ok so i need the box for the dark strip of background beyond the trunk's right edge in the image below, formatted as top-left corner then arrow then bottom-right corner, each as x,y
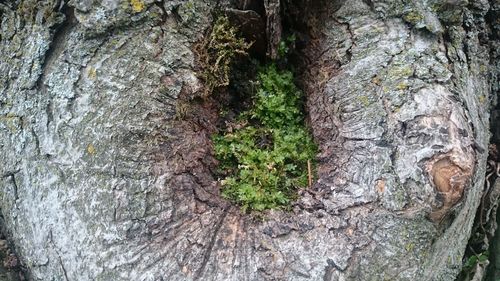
457,1 -> 500,281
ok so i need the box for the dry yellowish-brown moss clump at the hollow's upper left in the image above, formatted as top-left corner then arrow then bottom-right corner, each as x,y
201,16 -> 252,96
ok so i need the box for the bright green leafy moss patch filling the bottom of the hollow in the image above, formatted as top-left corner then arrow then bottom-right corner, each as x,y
213,64 -> 317,211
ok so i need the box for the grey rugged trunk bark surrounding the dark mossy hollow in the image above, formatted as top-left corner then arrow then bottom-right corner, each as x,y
0,0 -> 499,280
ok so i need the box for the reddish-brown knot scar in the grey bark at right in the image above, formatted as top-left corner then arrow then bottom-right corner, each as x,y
427,150 -> 474,221
